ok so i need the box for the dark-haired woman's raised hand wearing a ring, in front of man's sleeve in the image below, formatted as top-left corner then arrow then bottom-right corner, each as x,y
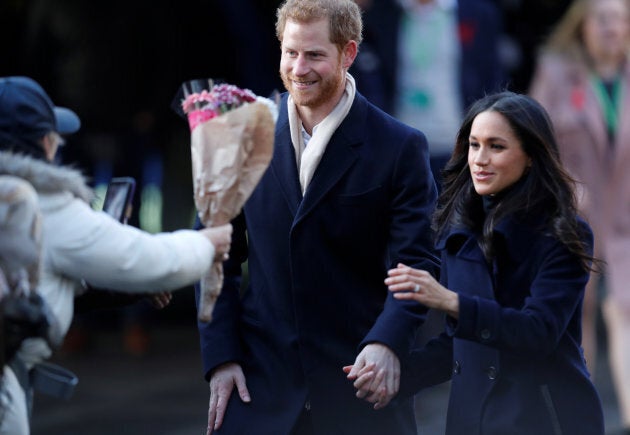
385,263 -> 459,319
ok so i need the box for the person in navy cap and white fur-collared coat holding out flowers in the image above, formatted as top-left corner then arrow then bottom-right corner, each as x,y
0,77 -> 232,434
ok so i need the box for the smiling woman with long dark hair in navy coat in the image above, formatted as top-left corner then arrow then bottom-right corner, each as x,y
348,92 -> 604,435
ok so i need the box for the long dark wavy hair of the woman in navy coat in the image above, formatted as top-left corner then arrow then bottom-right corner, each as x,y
433,92 -> 594,270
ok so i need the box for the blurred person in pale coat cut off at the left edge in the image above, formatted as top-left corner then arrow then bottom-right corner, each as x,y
0,175 -> 55,434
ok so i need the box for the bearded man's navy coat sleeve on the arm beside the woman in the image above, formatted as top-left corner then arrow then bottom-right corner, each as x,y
362,126 -> 440,358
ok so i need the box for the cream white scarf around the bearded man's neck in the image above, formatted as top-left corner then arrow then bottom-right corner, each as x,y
287,73 -> 356,194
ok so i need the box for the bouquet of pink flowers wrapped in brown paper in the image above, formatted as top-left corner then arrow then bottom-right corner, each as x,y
181,80 -> 277,322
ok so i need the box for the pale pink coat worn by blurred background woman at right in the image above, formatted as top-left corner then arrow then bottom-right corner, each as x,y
530,54 -> 630,313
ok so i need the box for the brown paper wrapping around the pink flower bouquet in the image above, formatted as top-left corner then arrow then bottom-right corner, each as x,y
190,101 -> 275,322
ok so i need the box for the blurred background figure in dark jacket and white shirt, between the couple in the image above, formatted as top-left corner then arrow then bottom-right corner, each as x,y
351,0 -> 505,191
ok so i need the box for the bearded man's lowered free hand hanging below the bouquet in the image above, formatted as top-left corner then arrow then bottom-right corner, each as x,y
206,363 -> 251,435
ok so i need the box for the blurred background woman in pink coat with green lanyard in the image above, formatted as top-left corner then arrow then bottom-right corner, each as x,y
530,0 -> 630,433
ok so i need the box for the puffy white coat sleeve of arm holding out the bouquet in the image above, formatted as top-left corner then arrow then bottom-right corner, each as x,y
44,199 -> 214,293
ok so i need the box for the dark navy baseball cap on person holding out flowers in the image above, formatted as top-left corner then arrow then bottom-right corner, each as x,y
0,77 -> 81,155
